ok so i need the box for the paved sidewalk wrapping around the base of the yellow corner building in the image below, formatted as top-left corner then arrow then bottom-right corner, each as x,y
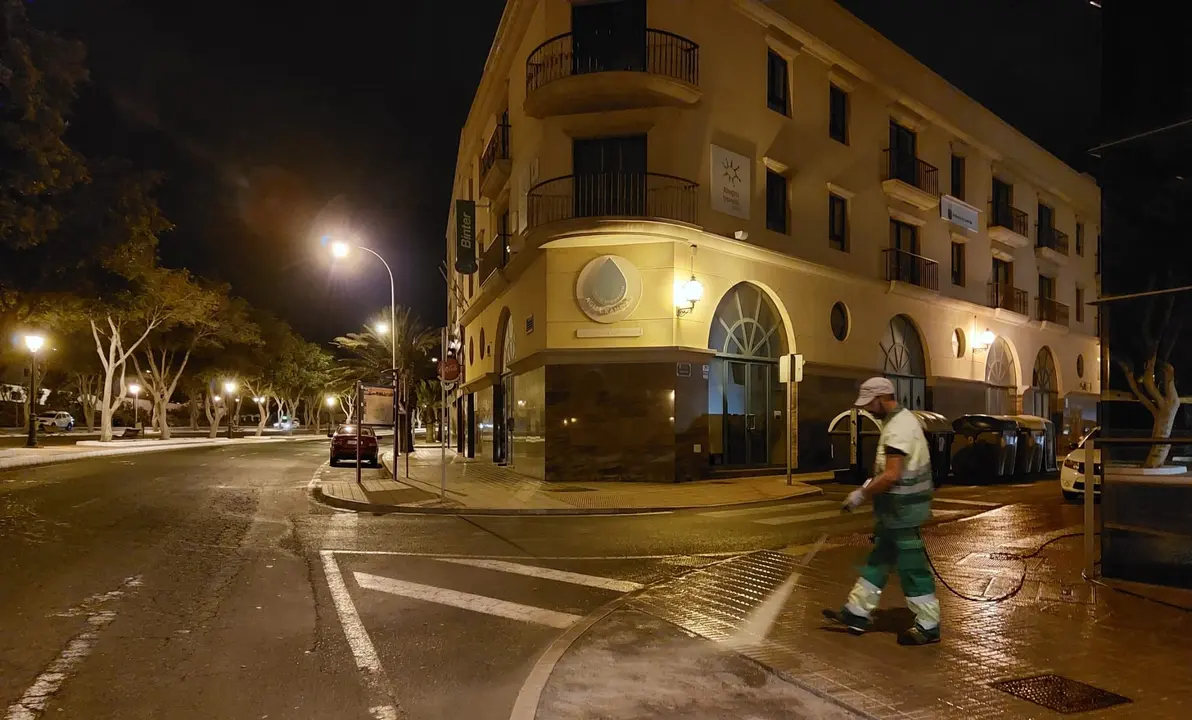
311,446 -> 830,515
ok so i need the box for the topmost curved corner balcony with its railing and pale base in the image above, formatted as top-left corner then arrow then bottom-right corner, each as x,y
524,30 -> 701,118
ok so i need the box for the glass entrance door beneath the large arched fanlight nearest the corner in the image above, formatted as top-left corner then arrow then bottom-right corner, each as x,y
722,360 -> 781,467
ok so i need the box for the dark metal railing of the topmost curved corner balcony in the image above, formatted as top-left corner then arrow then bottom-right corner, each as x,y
526,29 -> 700,93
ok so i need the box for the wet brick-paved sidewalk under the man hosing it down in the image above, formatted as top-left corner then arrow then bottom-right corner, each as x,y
633,505 -> 1192,720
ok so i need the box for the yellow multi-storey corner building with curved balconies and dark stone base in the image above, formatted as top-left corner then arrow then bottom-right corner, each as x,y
447,0 -> 1100,482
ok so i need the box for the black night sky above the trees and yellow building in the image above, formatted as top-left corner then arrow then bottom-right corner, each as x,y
31,0 -> 1100,340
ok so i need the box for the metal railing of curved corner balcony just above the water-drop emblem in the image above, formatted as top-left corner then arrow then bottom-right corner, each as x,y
527,173 -> 700,228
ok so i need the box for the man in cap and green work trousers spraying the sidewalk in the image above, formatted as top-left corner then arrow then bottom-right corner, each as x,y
824,378 -> 939,645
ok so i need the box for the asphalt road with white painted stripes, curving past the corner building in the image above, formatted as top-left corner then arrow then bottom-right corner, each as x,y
0,441 -> 1058,720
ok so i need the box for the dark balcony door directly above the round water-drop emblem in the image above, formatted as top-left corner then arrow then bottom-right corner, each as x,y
571,135 -> 646,217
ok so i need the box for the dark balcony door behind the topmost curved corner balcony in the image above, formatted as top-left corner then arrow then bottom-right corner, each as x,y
571,0 -> 646,75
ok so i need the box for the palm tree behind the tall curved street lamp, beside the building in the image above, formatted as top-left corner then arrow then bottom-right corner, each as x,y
331,306 -> 437,451
